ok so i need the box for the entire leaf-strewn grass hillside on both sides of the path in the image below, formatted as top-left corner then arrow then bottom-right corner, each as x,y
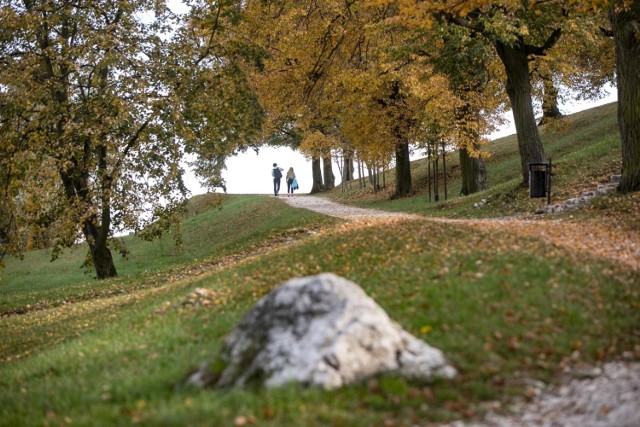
0,102 -> 640,426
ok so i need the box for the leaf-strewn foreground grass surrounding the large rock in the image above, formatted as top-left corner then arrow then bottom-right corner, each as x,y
0,216 -> 640,426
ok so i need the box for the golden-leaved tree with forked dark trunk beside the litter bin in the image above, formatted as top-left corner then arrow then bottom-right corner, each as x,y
384,1 -> 566,183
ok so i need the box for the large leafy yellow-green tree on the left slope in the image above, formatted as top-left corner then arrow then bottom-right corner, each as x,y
0,0 -> 258,279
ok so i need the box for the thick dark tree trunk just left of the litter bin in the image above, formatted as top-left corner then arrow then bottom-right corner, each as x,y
495,41 -> 545,184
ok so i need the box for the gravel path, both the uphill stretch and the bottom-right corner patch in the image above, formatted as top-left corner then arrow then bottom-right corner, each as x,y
283,196 -> 640,427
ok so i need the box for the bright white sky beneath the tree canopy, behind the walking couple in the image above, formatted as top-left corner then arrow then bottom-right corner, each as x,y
185,89 -> 617,195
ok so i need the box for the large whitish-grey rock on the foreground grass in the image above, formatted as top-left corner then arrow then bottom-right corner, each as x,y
186,273 -> 456,389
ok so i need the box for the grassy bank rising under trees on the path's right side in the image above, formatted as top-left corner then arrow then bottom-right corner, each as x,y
330,103 -> 621,217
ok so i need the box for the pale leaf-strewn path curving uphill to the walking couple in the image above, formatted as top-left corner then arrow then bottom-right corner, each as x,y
282,196 -> 640,271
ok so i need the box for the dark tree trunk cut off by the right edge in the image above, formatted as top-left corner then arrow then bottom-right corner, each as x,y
609,1 -> 640,193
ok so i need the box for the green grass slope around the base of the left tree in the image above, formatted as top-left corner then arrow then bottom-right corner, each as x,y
0,196 -> 336,314
